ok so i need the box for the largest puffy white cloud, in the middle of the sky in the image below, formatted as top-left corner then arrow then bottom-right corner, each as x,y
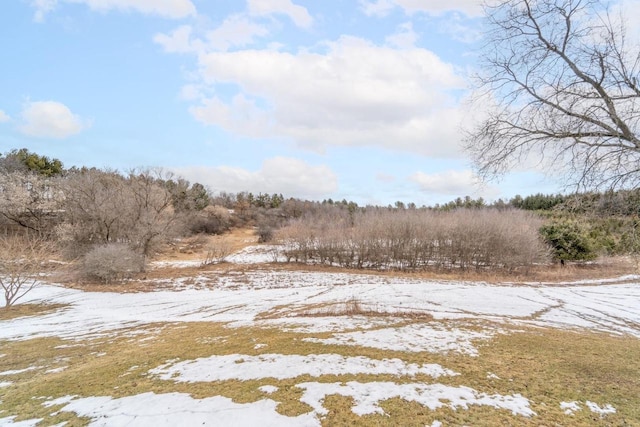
191,37 -> 464,156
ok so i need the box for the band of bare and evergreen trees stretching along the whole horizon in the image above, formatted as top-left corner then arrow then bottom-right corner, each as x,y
0,149 -> 640,278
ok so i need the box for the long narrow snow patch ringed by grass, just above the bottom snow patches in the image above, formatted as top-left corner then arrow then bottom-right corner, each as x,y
149,354 -> 458,382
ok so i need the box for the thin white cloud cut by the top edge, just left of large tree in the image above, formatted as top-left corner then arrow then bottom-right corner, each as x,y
360,0 -> 482,17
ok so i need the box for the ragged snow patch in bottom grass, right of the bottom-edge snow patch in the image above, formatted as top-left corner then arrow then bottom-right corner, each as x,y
296,381 -> 535,417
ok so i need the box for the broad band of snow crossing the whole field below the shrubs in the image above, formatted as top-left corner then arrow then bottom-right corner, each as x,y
0,270 -> 640,344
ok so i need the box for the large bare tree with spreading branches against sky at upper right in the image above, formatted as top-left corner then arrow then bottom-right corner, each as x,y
466,0 -> 640,189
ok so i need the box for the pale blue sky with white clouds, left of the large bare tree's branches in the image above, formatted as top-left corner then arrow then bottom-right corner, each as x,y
0,0 -> 635,206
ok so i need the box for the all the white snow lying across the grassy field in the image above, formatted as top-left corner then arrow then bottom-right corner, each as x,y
0,247 -> 640,426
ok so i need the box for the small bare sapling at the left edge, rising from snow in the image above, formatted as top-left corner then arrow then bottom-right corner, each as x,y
0,235 -> 51,309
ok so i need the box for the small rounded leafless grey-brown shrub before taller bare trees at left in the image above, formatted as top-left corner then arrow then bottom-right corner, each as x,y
81,243 -> 144,283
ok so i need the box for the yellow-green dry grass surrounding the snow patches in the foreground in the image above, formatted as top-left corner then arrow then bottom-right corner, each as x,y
0,323 -> 640,426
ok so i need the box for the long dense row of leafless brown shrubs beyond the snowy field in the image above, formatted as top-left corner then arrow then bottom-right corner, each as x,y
278,209 -> 548,270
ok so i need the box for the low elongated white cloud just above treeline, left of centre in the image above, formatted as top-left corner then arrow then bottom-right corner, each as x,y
173,157 -> 338,198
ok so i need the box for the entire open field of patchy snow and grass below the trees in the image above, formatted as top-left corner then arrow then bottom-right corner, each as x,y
0,246 -> 640,427
